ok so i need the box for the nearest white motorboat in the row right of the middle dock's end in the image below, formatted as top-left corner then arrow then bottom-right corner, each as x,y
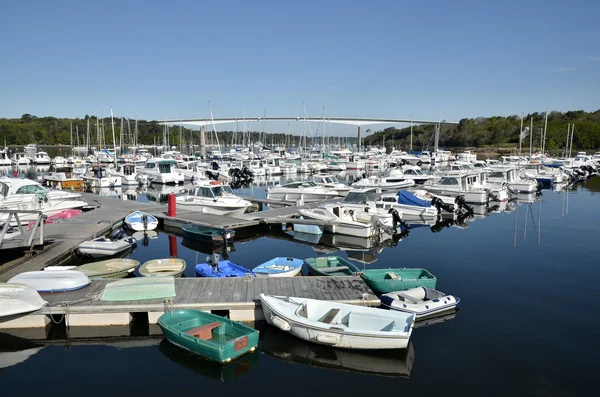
298,203 -> 395,238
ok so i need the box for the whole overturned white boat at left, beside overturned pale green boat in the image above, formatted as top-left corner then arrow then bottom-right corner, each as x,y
8,270 -> 91,292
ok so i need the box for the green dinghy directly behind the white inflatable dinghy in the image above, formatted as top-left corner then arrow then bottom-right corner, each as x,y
360,268 -> 437,294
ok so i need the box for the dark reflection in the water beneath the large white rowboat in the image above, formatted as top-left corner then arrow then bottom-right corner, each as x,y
259,324 -> 415,378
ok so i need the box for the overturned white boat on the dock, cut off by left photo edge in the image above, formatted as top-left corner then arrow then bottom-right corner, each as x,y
0,282 -> 48,322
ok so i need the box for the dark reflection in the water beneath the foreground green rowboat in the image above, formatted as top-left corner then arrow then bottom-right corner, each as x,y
158,339 -> 259,383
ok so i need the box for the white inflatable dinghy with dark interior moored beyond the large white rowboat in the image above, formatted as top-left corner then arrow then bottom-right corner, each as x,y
381,287 -> 460,320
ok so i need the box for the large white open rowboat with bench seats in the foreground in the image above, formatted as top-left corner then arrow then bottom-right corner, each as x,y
260,293 -> 415,349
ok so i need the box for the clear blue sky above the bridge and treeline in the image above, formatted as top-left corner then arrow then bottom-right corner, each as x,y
0,0 -> 600,135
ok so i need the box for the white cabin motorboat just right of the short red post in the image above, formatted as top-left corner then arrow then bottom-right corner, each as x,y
175,180 -> 252,216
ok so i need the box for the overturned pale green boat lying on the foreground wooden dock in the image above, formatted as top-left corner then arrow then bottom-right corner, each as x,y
100,276 -> 176,302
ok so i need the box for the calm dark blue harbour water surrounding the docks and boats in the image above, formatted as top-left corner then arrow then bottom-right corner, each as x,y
0,171 -> 600,397
